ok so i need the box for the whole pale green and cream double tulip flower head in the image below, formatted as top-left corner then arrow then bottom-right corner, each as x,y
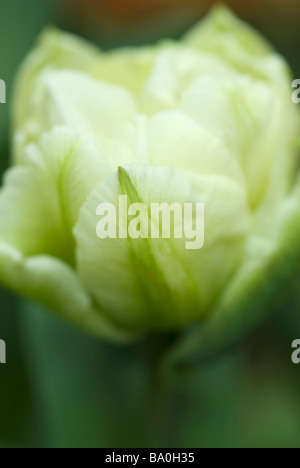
0,4 -> 300,348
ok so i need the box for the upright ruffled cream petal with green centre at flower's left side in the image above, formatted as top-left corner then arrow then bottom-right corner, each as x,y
0,128 -> 108,262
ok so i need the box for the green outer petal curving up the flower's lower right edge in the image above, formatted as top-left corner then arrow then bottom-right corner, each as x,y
165,184 -> 300,366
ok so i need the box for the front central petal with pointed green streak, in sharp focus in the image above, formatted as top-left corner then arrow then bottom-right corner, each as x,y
75,165 -> 249,330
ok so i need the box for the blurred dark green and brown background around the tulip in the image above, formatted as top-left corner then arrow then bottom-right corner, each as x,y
0,0 -> 300,448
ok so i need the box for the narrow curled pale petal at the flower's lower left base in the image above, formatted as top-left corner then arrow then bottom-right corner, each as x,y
0,242 -> 132,342
